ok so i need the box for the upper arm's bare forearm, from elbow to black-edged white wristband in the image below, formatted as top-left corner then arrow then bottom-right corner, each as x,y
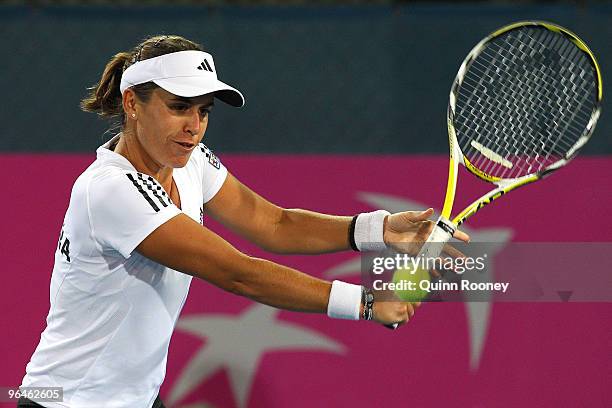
260,209 -> 352,254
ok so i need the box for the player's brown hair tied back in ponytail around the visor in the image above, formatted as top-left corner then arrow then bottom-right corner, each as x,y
81,35 -> 203,123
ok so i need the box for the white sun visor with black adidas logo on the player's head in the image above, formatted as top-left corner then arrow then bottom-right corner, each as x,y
119,51 -> 244,107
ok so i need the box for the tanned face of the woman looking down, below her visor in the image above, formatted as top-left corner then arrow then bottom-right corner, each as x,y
136,88 -> 214,168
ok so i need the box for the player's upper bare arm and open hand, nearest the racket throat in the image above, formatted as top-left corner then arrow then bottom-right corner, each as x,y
206,174 -> 469,256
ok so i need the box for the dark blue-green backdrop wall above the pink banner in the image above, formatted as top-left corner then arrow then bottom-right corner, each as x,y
0,4 -> 612,154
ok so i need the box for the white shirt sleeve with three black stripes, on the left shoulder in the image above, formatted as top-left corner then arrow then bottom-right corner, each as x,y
88,172 -> 181,258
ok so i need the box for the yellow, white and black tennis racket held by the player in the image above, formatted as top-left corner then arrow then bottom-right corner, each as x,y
393,21 -> 602,327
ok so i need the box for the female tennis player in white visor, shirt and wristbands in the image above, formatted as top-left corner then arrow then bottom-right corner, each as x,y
18,36 -> 468,408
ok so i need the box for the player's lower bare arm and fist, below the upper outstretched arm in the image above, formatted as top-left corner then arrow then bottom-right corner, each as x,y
136,214 -> 414,324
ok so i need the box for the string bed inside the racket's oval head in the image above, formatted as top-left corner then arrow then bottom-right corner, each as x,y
454,27 -> 595,178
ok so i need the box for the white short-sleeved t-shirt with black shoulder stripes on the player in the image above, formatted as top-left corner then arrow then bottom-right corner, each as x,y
22,135 -> 227,408
